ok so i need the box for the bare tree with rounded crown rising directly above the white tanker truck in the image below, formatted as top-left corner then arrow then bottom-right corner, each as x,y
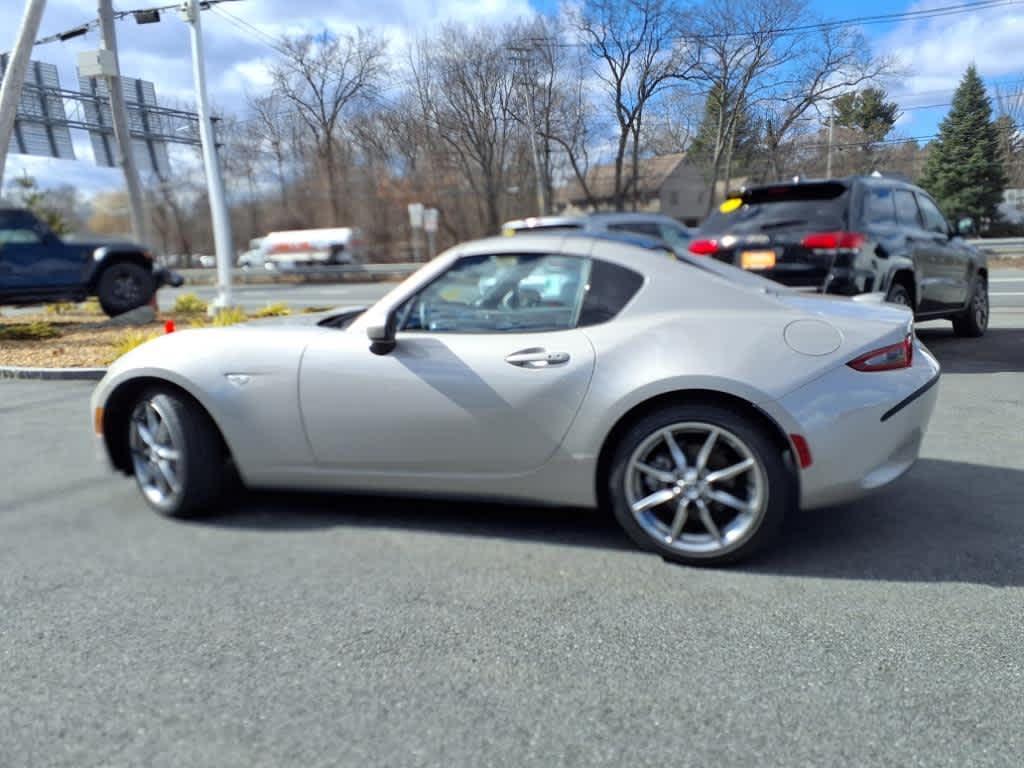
272,29 -> 387,223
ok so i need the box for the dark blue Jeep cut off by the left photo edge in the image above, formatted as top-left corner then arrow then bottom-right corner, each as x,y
0,206 -> 182,316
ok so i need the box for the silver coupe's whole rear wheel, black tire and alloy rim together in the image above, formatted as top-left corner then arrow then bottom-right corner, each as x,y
608,403 -> 795,565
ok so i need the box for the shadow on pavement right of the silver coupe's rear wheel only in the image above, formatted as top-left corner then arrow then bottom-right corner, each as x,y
744,459 -> 1024,587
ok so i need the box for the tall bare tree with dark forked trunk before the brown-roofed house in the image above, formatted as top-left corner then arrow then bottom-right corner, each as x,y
568,0 -> 693,211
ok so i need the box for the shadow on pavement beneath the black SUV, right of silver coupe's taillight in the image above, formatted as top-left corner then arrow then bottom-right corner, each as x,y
918,324 -> 1024,374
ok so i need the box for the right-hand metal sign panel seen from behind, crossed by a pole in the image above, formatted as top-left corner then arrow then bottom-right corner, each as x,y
78,73 -> 172,178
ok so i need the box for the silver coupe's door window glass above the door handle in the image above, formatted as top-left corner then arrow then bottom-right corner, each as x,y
398,254 -> 590,334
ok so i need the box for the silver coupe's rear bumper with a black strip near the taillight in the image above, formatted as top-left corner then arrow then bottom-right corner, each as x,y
780,340 -> 940,508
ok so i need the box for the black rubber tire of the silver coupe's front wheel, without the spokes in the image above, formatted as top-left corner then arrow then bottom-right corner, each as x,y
124,388 -> 226,518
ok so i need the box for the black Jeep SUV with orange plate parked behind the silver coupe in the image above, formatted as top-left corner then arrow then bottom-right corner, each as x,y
689,176 -> 988,336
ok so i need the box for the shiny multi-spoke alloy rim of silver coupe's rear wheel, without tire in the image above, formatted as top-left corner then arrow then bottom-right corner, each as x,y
624,422 -> 768,556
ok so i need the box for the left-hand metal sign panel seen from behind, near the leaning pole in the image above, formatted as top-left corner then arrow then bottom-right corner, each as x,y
0,53 -> 75,160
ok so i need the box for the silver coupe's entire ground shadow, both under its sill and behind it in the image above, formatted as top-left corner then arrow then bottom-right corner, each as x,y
203,459 -> 1024,587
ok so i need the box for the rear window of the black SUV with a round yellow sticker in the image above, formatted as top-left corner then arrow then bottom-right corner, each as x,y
700,181 -> 849,234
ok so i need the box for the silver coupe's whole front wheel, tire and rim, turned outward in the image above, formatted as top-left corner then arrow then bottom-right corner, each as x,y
127,389 -> 227,517
